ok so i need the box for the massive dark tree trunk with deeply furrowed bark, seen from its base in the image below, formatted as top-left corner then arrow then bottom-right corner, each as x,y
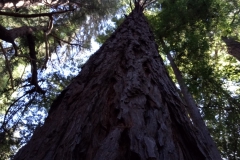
15,8 -> 219,160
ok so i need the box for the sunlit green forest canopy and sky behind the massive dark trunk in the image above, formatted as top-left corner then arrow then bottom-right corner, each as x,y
0,0 -> 240,160
